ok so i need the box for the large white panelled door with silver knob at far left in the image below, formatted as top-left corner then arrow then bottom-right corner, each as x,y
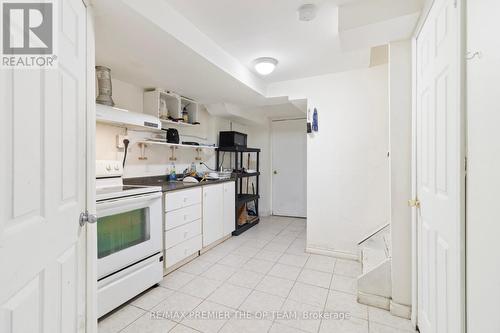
0,0 -> 86,333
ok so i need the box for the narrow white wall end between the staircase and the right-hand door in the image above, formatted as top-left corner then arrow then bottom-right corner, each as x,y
389,41 -> 412,308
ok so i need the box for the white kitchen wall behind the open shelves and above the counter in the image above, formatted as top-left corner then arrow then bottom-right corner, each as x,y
96,79 -> 271,216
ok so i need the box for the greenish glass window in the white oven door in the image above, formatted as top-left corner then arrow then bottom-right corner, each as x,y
97,208 -> 150,259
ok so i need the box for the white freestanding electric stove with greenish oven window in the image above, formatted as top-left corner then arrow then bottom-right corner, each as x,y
96,161 -> 163,317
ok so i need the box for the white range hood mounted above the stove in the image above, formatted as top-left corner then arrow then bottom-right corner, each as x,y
96,104 -> 161,130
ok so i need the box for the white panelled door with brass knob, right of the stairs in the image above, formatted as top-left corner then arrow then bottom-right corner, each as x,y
416,0 -> 465,333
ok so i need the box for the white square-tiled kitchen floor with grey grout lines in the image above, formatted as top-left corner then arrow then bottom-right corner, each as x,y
99,217 -> 414,333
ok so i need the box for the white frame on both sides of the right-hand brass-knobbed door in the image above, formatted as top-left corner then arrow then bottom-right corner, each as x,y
411,0 -> 467,333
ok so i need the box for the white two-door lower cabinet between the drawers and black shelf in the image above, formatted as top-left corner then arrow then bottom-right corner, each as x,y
202,182 -> 235,247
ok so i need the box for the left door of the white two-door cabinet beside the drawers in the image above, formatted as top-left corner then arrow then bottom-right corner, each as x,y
202,184 -> 224,246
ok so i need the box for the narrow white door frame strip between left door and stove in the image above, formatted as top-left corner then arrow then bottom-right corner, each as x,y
82,0 -> 97,333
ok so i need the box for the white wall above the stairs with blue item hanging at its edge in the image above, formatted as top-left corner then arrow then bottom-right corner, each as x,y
269,65 -> 389,258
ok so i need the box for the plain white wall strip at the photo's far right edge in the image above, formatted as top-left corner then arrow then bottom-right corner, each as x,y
466,0 -> 500,333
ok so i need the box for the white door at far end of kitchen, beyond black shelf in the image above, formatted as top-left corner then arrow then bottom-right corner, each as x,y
272,119 -> 307,217
